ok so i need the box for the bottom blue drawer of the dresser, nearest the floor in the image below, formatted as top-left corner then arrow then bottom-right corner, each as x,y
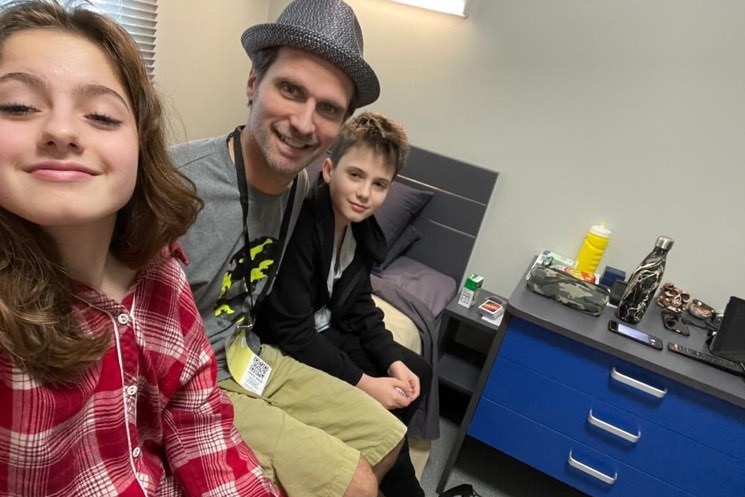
468,398 -> 703,497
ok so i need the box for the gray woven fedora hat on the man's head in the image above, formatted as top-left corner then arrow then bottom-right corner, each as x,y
241,0 -> 380,107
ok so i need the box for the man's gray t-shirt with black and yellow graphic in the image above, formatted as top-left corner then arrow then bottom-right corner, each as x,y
169,136 -> 308,381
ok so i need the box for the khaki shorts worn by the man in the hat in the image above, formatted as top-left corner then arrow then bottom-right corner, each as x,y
220,345 -> 406,497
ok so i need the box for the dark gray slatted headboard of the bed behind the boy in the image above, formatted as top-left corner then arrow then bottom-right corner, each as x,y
308,147 -> 498,285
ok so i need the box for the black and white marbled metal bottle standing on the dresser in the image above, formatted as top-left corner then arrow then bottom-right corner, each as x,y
616,236 -> 673,324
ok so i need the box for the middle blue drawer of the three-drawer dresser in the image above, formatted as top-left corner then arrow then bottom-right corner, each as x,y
483,358 -> 745,497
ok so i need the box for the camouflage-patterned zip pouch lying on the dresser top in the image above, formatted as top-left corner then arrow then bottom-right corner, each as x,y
528,266 -> 610,316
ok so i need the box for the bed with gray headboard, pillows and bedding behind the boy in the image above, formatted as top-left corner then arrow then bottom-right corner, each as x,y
308,147 -> 498,475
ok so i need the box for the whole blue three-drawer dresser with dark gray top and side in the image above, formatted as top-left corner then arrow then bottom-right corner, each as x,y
440,270 -> 745,497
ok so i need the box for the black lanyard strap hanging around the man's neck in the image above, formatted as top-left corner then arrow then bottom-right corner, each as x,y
231,126 -> 297,320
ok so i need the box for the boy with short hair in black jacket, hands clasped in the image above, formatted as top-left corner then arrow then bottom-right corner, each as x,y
256,112 -> 432,496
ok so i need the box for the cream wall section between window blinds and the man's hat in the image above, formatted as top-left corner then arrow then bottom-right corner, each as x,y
155,0 -> 269,142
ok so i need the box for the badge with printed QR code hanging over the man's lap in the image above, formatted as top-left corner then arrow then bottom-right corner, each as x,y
226,321 -> 272,395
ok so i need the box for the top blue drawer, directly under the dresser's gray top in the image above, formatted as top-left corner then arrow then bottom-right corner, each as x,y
498,317 -> 745,461
